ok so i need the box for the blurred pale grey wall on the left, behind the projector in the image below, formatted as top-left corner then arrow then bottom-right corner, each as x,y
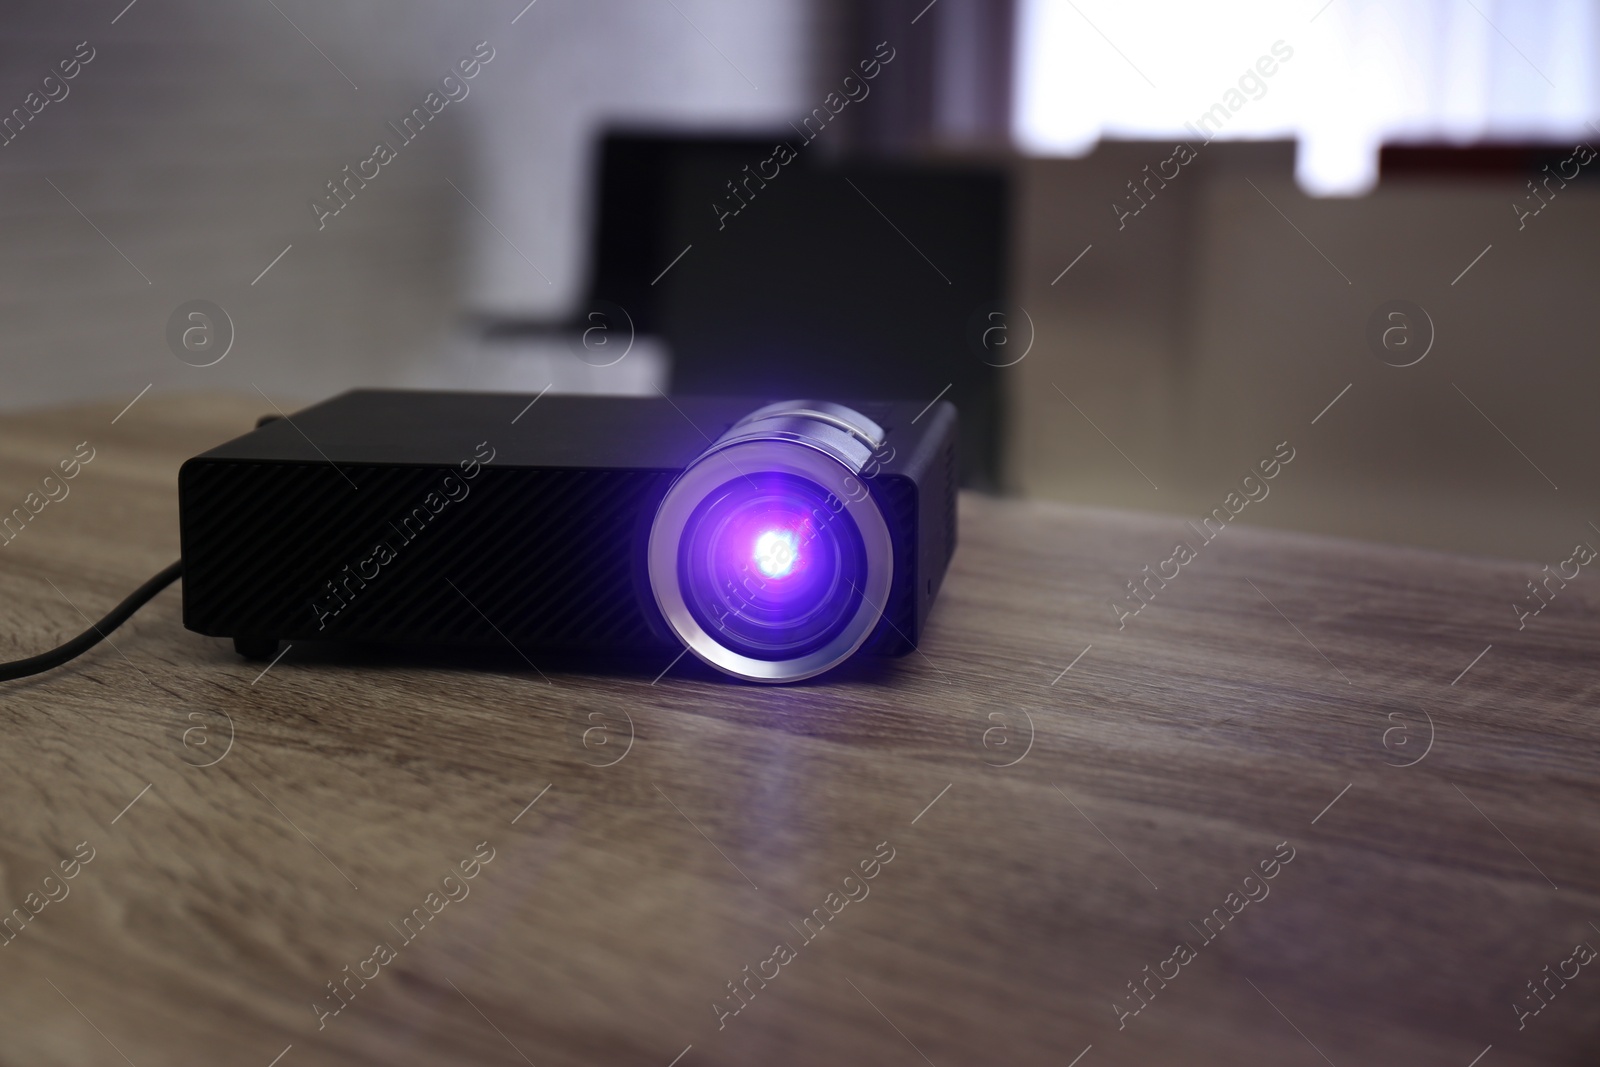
0,0 -> 819,408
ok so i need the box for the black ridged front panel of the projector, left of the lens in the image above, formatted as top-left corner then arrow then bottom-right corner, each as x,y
182,462 -> 672,651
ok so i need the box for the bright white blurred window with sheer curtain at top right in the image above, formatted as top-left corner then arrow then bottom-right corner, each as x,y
1013,0 -> 1600,195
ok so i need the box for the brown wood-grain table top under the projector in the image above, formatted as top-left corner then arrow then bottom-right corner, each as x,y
0,395 -> 1600,1067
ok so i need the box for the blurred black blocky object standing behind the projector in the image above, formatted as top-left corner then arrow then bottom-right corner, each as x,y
590,133 -> 1008,490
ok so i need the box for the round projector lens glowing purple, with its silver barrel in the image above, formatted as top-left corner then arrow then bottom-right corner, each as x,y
650,402 -> 893,681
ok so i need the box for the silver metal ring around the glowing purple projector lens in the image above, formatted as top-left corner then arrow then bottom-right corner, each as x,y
648,422 -> 894,683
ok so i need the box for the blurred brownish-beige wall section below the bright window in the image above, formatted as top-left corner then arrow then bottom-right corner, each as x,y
1008,142 -> 1600,560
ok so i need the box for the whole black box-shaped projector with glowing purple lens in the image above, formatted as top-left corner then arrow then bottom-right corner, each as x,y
179,390 -> 957,681
